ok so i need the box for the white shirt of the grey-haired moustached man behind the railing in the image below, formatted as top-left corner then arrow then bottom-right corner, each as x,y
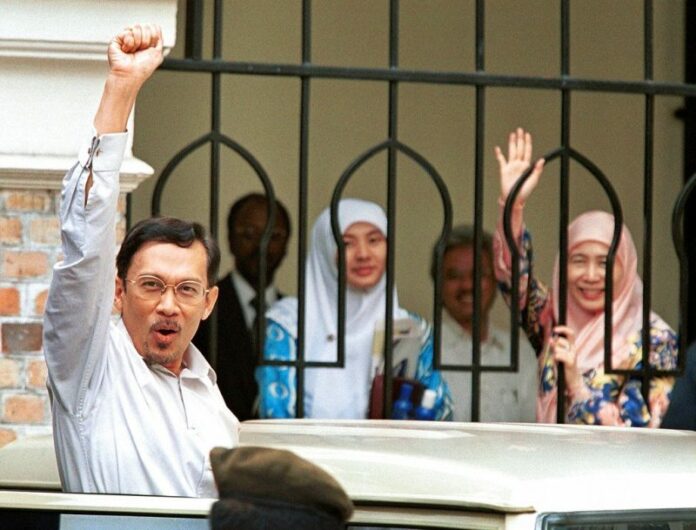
442,310 -> 537,422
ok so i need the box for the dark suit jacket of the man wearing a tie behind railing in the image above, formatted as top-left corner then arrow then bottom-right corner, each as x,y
193,274 -> 259,421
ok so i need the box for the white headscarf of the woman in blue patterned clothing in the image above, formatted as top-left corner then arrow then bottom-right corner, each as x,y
268,199 -> 407,419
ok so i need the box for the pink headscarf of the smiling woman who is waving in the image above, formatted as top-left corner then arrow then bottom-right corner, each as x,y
537,210 -> 643,422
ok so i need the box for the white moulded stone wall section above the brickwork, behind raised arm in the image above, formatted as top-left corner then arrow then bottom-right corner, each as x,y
0,0 -> 177,182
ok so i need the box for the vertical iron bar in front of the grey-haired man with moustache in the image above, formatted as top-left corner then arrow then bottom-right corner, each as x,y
471,0 -> 486,421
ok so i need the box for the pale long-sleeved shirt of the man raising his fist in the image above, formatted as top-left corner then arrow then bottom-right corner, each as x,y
44,133 -> 239,497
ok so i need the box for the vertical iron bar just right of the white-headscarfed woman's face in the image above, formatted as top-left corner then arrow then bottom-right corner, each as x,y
383,0 -> 399,418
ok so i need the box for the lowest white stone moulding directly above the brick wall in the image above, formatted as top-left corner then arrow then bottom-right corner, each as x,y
0,155 -> 155,193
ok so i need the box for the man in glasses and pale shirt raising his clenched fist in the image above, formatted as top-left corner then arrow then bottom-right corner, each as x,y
44,25 -> 239,497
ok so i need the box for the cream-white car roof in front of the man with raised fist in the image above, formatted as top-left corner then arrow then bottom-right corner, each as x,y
0,420 -> 696,514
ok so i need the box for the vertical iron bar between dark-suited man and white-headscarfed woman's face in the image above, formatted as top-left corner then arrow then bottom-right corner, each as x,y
295,0 -> 312,418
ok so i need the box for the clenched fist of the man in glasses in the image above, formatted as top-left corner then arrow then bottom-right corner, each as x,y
108,24 -> 164,84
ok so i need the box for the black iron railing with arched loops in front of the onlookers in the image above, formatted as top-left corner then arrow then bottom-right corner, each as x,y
145,0 -> 696,421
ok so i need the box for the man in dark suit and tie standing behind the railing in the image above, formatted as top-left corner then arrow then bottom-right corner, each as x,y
193,193 -> 290,421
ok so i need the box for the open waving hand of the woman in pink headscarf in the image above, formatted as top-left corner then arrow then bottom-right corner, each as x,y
495,127 -> 544,205
